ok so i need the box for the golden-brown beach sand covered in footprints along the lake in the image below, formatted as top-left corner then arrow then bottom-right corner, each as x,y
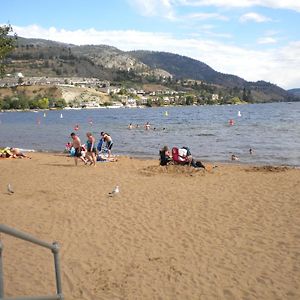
0,153 -> 300,300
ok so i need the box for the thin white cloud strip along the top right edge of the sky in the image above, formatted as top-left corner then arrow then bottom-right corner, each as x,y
175,0 -> 300,12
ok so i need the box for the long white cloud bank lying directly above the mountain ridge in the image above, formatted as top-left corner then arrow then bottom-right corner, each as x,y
13,25 -> 300,88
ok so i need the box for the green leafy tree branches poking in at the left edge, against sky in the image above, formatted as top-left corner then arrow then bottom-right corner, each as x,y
0,25 -> 17,77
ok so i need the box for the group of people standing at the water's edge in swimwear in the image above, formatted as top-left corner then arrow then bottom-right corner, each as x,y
66,132 -> 114,166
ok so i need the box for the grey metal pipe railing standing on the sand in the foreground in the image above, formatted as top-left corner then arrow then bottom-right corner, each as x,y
0,224 -> 64,300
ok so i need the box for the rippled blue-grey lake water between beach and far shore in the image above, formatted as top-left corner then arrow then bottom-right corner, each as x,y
0,102 -> 300,166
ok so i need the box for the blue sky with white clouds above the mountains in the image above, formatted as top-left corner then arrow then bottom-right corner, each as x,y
0,0 -> 300,89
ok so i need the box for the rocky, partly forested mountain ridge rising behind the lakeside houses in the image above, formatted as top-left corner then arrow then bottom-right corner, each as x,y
2,37 -> 299,102
